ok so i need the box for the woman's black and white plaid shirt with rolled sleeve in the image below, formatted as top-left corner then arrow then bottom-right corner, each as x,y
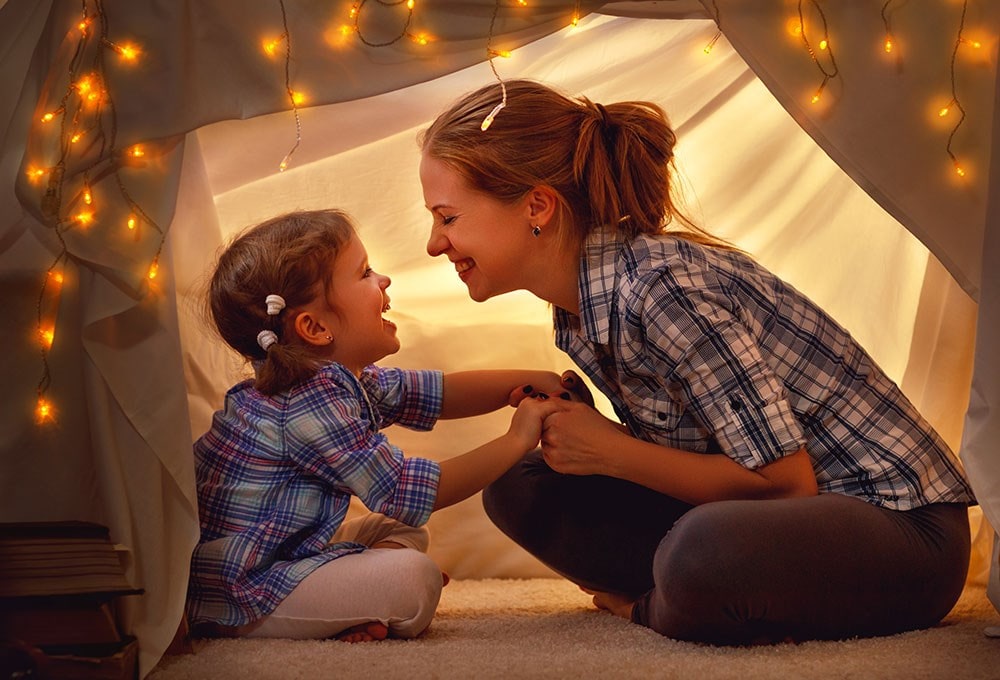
554,234 -> 975,510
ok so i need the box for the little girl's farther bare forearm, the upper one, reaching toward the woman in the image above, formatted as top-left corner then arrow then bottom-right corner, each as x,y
441,369 -> 559,419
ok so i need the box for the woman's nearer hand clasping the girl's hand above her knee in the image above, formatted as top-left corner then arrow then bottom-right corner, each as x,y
542,400 -> 630,476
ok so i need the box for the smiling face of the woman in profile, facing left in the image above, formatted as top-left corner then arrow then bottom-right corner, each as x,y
420,154 -> 538,302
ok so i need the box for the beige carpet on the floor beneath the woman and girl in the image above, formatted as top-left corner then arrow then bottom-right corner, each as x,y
148,579 -> 1000,680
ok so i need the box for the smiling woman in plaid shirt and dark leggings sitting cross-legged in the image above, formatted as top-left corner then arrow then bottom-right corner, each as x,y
420,81 -> 975,644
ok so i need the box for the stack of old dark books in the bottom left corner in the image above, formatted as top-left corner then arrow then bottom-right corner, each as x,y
0,521 -> 142,678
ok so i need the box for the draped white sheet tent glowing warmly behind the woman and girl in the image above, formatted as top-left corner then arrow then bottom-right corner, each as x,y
0,0 -> 1000,675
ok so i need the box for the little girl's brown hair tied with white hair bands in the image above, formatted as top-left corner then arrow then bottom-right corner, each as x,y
207,210 -> 355,395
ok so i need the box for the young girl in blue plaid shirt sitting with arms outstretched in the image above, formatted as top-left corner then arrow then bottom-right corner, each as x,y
188,210 -> 579,641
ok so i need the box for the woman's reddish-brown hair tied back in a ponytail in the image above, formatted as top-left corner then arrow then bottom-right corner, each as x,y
419,80 -> 730,248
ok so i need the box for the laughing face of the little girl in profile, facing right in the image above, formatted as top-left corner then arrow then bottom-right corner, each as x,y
306,235 -> 399,375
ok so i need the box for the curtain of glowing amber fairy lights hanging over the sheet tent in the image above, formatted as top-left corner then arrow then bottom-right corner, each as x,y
24,0 -> 982,423
